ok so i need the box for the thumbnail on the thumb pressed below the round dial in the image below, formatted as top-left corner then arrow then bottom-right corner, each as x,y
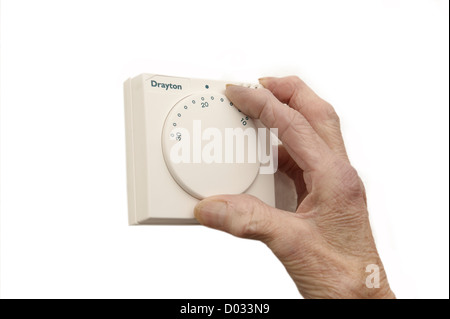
194,200 -> 227,228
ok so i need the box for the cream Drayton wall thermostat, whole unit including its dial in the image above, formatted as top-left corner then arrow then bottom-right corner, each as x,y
124,74 -> 278,225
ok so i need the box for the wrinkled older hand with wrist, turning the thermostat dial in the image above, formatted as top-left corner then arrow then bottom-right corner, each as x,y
195,77 -> 395,298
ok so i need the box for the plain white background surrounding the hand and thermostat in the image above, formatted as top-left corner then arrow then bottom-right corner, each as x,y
0,0 -> 449,298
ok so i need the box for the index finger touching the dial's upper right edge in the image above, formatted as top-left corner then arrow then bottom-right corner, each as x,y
226,85 -> 333,172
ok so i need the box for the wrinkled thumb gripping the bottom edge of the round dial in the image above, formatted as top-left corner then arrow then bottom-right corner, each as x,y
194,195 -> 306,255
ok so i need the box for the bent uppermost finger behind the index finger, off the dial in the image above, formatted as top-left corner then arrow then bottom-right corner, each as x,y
259,76 -> 347,159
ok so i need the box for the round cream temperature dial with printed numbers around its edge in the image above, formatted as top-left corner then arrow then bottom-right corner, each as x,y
162,92 -> 260,199
